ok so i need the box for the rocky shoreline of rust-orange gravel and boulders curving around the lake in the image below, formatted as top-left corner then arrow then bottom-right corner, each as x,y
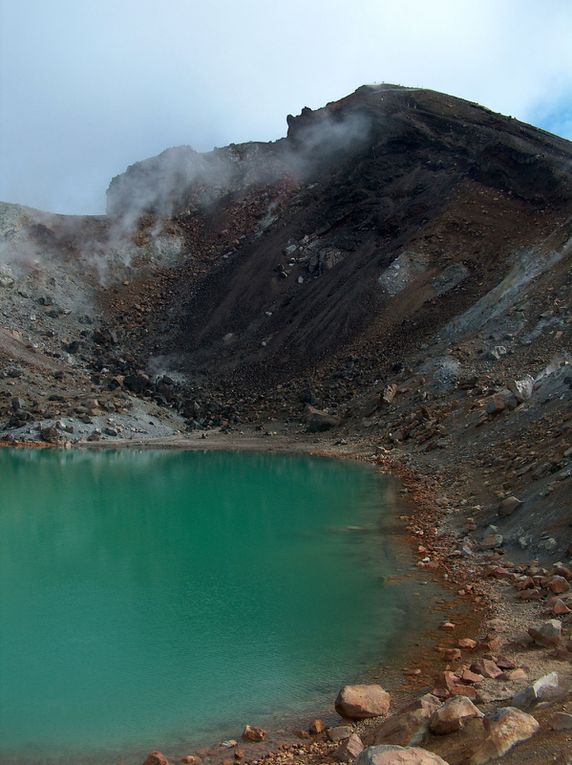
6,432 -> 572,765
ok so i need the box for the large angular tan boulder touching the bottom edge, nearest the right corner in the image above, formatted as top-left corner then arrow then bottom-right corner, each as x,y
467,707 -> 540,765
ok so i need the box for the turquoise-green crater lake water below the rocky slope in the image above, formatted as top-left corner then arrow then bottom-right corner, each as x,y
0,449 -> 403,757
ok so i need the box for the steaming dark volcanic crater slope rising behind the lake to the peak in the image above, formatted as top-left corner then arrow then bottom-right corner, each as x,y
0,86 -> 572,559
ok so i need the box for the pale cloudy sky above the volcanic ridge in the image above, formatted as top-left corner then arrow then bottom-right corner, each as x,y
0,0 -> 572,213
